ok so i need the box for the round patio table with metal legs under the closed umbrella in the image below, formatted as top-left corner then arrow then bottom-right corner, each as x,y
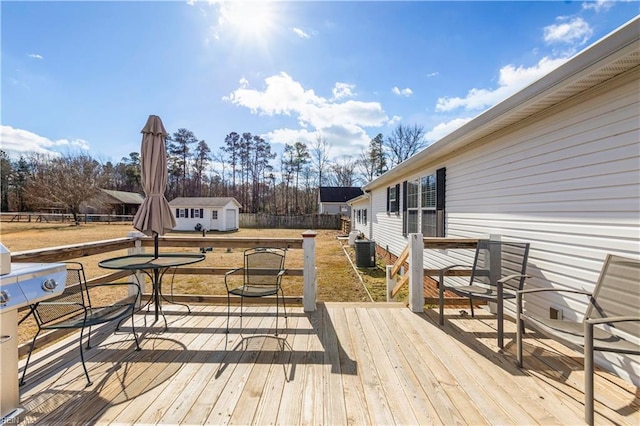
98,253 -> 205,329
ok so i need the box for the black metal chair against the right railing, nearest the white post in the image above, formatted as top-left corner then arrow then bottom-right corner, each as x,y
439,240 -> 530,325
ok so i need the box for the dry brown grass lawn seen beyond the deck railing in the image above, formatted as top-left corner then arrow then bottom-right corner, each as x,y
0,222 -> 384,341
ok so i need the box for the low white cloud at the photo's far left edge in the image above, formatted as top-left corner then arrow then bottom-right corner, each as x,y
0,125 -> 89,157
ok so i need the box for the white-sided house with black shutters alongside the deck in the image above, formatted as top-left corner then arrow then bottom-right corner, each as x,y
362,18 -> 640,385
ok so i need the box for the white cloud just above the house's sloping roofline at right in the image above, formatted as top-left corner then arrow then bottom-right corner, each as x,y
436,57 -> 567,112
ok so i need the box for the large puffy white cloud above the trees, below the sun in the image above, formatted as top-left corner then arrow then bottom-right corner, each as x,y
223,72 -> 388,151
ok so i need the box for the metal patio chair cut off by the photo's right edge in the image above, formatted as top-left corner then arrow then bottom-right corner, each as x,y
516,255 -> 640,425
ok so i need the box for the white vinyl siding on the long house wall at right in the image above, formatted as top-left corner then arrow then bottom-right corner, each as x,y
364,68 -> 640,384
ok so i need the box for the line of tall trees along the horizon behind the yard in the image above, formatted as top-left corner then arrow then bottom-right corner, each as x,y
0,124 -> 426,220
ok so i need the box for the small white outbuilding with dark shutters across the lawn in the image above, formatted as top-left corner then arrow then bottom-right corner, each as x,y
169,197 -> 242,231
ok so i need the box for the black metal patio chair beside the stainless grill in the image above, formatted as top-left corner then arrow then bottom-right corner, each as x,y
20,262 -> 140,386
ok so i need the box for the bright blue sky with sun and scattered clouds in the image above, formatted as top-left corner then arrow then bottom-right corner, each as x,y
0,1 -> 639,162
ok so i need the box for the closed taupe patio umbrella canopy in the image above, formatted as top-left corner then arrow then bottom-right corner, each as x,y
133,115 -> 176,235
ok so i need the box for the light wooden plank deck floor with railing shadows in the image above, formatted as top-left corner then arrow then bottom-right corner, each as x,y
21,303 -> 640,425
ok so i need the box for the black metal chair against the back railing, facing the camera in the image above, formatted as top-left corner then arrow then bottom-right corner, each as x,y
224,247 -> 287,336
